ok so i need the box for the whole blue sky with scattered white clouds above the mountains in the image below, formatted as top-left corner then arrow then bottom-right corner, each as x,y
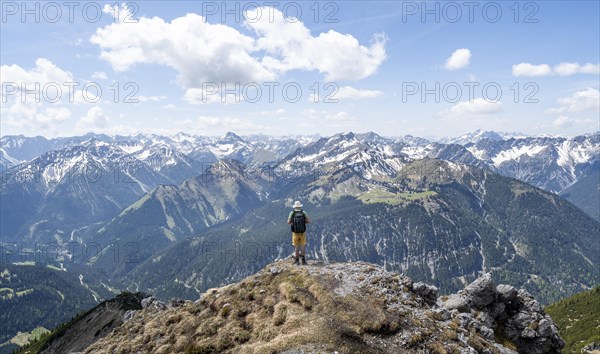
0,1 -> 600,137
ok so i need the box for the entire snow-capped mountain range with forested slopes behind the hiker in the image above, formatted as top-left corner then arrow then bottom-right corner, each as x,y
0,132 -> 600,352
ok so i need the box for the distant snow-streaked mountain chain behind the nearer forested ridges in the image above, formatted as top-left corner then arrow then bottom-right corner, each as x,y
0,131 -> 600,246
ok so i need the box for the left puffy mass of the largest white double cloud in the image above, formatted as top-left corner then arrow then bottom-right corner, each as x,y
90,13 -> 274,87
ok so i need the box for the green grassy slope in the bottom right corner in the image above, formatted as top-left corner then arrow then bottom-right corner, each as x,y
546,286 -> 600,353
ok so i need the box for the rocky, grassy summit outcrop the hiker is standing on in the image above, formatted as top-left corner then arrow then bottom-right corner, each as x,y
47,260 -> 564,354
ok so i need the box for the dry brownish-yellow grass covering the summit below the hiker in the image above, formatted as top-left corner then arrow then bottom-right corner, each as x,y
86,260 -> 500,354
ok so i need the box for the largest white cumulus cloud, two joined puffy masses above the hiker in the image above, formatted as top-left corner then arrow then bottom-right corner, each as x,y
90,7 -> 386,88
